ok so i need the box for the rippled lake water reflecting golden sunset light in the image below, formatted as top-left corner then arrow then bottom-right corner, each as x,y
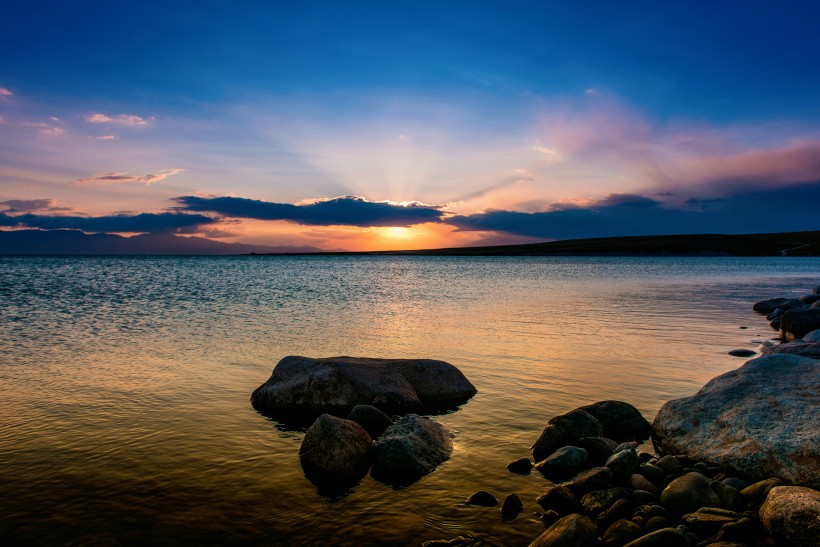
0,257 -> 820,545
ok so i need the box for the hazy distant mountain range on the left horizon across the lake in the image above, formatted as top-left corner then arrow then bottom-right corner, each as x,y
0,230 -> 322,255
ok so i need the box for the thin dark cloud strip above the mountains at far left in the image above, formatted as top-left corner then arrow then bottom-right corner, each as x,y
0,213 -> 219,233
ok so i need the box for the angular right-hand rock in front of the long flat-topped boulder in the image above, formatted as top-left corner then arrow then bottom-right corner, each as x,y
372,414 -> 453,483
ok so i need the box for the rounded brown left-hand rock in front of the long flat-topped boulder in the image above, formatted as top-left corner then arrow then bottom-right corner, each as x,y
299,414 -> 373,483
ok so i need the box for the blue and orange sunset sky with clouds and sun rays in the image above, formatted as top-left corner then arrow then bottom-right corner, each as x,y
0,0 -> 820,250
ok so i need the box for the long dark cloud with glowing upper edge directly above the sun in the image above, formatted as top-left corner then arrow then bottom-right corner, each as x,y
176,196 -> 444,227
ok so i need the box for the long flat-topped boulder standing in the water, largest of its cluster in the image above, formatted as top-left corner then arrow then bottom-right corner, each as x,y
251,356 -> 476,415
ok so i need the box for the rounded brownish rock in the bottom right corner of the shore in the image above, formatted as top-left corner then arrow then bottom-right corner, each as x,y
760,486 -> 820,547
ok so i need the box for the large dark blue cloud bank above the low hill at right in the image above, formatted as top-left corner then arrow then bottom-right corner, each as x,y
446,182 -> 820,239
